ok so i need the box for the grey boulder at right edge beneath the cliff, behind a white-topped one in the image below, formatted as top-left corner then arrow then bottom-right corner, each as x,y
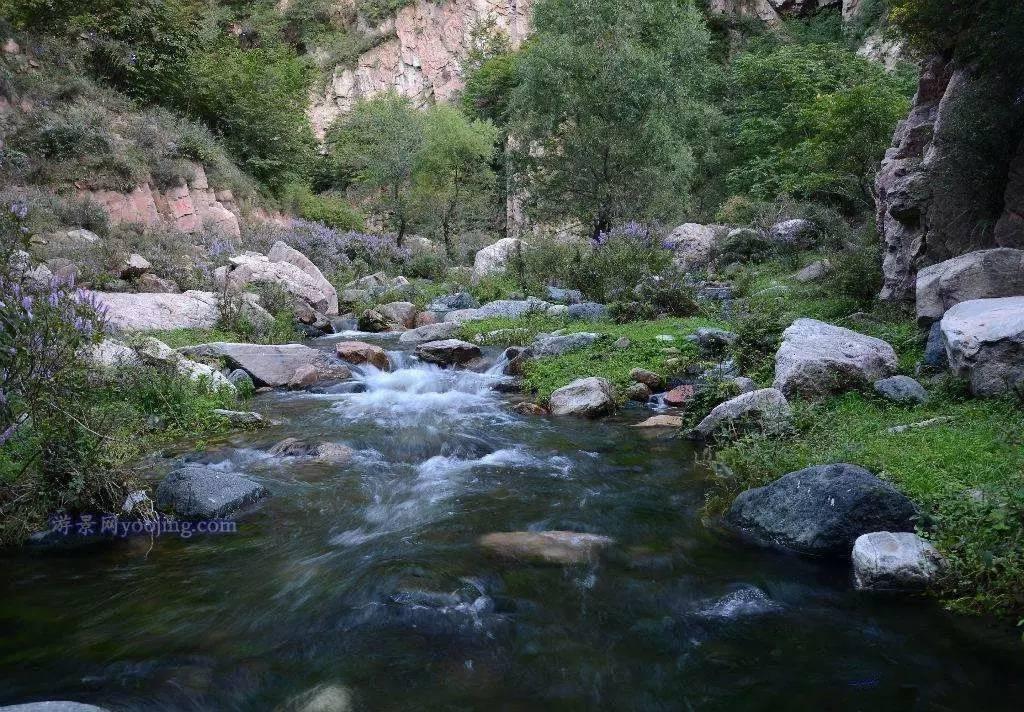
916,247 -> 1024,326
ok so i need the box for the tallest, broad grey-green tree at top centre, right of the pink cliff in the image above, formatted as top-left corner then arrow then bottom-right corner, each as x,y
509,0 -> 715,237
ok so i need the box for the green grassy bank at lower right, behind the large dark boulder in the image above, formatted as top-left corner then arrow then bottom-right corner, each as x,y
711,389 -> 1024,617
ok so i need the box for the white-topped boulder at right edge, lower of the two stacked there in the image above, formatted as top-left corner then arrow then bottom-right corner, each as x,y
941,296 -> 1024,395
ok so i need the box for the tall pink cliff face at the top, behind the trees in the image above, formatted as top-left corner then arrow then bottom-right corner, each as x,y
309,0 -> 532,138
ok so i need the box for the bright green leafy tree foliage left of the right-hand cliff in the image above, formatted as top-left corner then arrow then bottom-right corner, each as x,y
728,43 -> 911,209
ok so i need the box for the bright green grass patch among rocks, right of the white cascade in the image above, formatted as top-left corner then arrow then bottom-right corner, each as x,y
460,317 -> 722,402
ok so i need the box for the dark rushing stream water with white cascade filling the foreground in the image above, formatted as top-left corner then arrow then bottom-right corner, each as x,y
0,339 -> 1024,712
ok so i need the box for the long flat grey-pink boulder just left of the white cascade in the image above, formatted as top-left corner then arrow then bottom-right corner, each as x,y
178,341 -> 352,388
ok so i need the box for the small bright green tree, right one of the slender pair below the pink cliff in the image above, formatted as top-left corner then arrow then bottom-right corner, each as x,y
414,104 -> 498,257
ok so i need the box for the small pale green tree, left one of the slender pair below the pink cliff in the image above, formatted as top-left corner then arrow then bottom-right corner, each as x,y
327,93 -> 424,245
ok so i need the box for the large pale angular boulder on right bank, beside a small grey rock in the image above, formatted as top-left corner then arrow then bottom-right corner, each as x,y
773,319 -> 897,396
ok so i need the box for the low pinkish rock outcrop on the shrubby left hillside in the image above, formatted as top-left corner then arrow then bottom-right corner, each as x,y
78,164 -> 242,237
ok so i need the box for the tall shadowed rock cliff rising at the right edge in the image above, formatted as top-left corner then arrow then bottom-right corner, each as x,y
876,57 -> 1024,301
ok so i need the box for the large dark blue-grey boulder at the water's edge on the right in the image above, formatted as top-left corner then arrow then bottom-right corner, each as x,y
726,464 -> 916,556
